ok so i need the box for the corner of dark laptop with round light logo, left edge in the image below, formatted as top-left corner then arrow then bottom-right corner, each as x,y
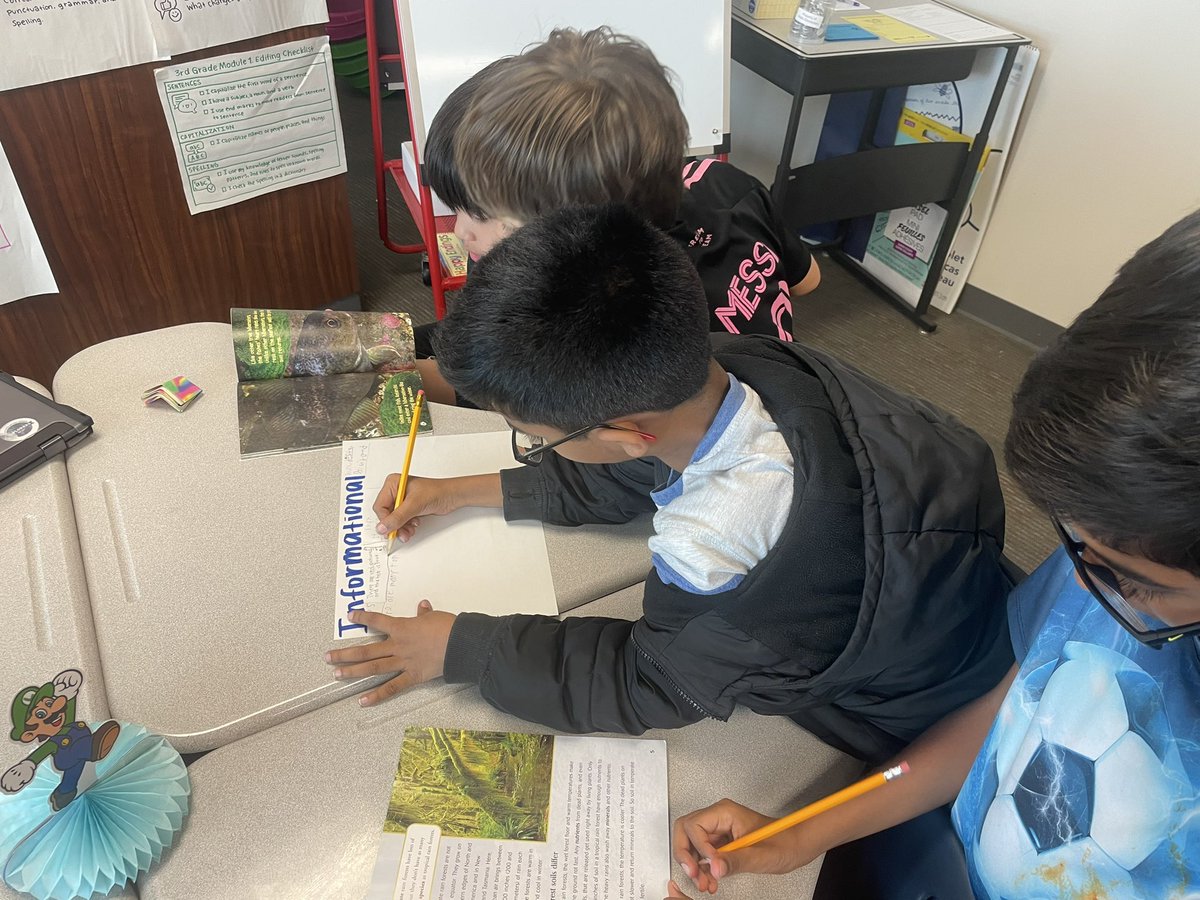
0,372 -> 92,488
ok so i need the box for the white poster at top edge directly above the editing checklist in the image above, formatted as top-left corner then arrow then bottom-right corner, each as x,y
142,0 -> 329,56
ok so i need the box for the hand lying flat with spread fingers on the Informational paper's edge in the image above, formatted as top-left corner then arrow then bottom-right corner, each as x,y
325,600 -> 455,707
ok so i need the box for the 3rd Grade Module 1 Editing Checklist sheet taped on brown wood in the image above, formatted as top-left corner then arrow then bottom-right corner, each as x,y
155,36 -> 346,215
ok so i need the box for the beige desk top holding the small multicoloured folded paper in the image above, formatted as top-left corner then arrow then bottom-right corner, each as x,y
54,323 -> 649,752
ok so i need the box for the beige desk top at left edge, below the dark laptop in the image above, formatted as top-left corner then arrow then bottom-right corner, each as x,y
0,378 -> 137,900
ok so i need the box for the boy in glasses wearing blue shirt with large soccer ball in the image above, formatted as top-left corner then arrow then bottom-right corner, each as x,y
672,212 -> 1200,900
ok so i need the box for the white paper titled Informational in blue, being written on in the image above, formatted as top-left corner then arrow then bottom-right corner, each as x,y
334,431 -> 558,638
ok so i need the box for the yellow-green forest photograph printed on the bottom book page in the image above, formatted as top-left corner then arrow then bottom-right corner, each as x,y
384,728 -> 554,841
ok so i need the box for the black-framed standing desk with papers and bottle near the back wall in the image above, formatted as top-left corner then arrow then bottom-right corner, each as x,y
731,0 -> 1030,331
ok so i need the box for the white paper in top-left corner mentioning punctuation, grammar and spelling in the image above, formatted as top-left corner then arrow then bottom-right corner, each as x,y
0,0 -> 166,91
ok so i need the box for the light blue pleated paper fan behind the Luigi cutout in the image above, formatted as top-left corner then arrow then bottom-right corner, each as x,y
0,722 -> 191,900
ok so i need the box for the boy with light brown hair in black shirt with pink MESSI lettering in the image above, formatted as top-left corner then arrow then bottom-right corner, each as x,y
425,28 -> 821,348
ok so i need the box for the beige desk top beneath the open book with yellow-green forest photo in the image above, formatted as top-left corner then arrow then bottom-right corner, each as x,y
138,586 -> 862,900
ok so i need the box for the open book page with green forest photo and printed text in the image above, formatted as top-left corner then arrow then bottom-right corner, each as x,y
367,728 -> 671,900
